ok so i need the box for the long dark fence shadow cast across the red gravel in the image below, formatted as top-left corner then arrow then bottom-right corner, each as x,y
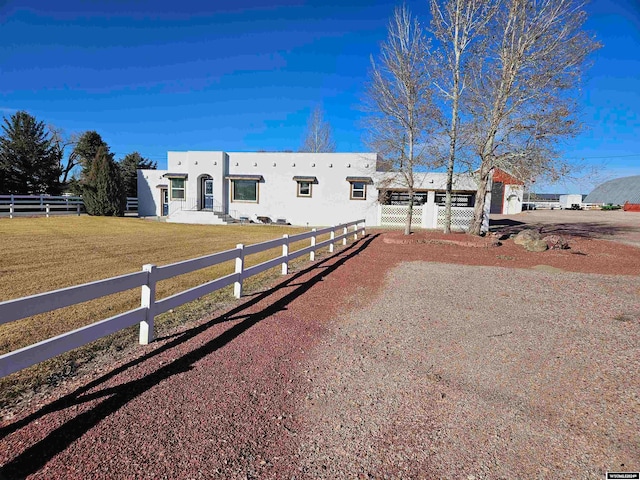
0,234 -> 378,480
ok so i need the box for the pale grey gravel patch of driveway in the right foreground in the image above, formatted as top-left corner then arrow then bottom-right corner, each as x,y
300,262 -> 640,479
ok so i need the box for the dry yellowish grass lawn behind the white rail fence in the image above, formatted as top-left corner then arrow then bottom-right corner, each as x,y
0,216 -> 322,407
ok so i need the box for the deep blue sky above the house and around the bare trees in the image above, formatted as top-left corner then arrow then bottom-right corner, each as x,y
0,0 -> 640,193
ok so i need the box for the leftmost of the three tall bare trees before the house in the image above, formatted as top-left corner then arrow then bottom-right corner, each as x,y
365,6 -> 434,235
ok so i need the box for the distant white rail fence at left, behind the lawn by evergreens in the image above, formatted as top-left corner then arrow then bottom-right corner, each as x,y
0,195 -> 138,218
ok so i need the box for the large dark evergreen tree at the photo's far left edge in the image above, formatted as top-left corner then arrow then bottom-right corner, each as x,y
0,111 -> 61,195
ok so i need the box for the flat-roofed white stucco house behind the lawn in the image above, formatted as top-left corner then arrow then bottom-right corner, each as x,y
138,151 -> 512,232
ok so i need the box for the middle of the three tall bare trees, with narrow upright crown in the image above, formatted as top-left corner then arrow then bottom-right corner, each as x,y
429,0 -> 498,233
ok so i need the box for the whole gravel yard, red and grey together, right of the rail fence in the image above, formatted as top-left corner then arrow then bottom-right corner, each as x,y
0,211 -> 640,480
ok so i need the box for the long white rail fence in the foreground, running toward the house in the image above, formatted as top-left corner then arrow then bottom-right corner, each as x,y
0,220 -> 366,378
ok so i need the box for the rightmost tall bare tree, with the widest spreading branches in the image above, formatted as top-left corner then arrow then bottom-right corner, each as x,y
469,0 -> 599,235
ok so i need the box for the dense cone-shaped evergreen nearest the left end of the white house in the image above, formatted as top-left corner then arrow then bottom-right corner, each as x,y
82,146 -> 127,217
